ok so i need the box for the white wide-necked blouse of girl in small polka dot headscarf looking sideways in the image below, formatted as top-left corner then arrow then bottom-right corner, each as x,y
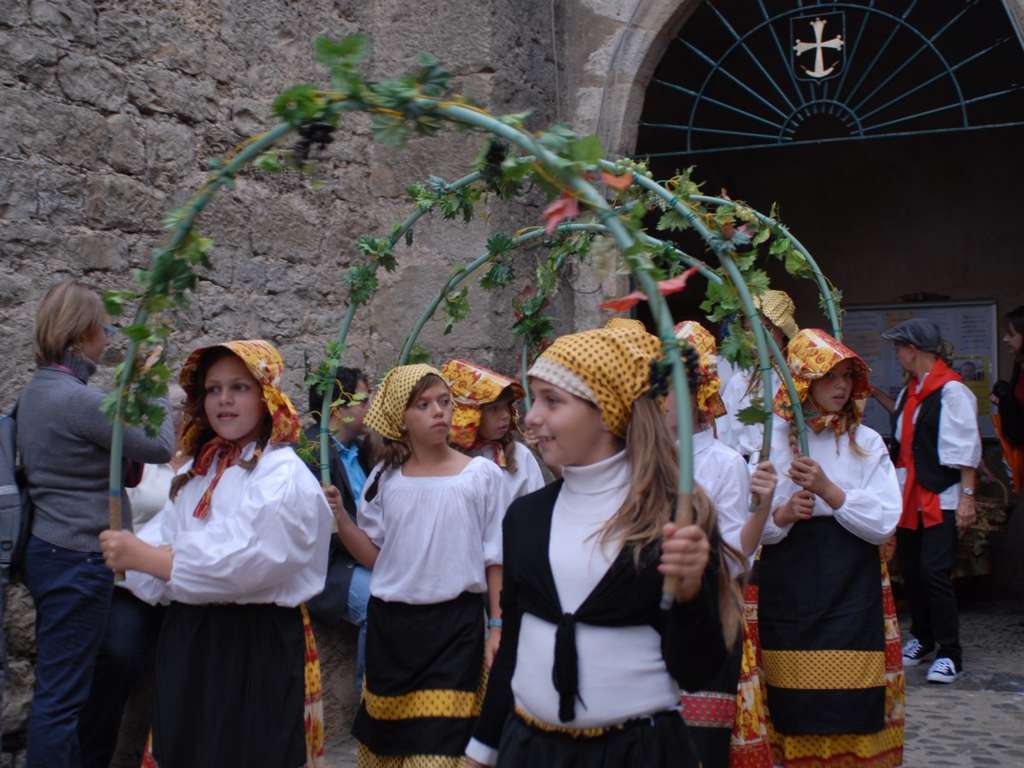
356,457 -> 511,604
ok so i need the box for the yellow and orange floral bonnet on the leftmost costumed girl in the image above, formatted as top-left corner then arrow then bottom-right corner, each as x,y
178,339 -> 302,454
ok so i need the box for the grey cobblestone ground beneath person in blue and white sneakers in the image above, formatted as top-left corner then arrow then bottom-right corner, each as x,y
328,603 -> 1024,768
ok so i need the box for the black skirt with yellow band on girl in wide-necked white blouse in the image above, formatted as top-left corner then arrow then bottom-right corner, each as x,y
352,592 -> 483,764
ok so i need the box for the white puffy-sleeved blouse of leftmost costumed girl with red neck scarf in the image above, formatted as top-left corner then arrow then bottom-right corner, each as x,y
126,443 -> 332,607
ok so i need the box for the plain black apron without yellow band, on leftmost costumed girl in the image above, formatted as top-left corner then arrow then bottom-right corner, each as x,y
153,603 -> 306,768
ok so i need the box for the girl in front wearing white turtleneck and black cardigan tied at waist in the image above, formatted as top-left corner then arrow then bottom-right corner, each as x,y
467,319 -> 741,768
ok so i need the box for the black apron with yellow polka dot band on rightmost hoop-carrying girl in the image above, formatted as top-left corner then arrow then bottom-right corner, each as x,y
758,517 -> 886,735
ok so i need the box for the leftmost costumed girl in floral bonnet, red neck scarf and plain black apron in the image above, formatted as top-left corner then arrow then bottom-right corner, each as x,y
100,340 -> 331,768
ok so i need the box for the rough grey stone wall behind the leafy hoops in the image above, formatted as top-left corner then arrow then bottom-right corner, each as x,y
0,0 -> 572,407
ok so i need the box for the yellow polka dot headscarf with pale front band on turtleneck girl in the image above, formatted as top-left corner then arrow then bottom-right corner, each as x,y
528,317 -> 662,437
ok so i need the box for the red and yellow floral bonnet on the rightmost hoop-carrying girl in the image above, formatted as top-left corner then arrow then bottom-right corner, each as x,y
774,328 -> 871,434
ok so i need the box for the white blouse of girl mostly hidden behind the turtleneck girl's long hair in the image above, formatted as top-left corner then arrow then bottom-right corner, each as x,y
693,429 -> 751,575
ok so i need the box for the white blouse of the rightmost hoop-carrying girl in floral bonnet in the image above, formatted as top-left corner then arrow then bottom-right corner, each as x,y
761,416 -> 903,545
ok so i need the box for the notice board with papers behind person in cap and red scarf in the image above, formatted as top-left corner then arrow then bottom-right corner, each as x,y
843,300 -> 999,437
